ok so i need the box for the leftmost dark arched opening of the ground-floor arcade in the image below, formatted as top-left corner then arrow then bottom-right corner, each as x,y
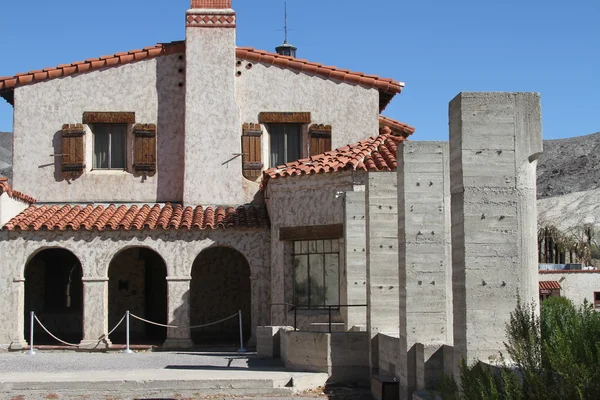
24,249 -> 83,345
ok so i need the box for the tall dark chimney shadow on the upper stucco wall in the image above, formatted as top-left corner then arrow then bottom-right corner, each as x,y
156,54 -> 185,203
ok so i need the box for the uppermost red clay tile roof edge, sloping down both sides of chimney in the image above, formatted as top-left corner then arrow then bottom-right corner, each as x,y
0,41 -> 404,110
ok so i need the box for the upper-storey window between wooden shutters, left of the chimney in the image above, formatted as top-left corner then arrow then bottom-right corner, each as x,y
92,124 -> 127,170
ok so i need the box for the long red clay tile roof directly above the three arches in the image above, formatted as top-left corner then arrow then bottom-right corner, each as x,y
3,204 -> 269,231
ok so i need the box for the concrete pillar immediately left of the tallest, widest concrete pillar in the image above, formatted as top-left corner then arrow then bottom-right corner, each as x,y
397,141 -> 452,387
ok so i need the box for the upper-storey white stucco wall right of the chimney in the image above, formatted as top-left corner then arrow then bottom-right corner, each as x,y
236,60 -> 379,195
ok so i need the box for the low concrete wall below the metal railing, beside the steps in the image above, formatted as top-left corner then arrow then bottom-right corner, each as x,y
280,329 -> 369,385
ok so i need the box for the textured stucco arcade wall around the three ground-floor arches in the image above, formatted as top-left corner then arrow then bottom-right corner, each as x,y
0,229 -> 270,346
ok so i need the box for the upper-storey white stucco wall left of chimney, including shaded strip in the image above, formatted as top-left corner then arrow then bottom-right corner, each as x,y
13,54 -> 185,202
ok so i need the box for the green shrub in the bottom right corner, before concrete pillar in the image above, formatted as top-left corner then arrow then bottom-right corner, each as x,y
440,298 -> 600,400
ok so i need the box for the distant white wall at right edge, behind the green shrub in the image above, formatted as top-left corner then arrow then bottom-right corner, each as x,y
539,271 -> 600,306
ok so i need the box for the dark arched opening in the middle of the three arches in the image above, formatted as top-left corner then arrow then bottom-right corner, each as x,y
108,247 -> 167,344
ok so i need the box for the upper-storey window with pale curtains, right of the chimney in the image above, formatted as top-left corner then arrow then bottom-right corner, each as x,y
269,124 -> 302,167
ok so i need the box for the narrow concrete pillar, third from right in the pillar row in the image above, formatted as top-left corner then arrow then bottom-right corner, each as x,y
366,172 -> 406,392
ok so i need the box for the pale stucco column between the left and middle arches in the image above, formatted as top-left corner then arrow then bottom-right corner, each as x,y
79,277 -> 111,349
